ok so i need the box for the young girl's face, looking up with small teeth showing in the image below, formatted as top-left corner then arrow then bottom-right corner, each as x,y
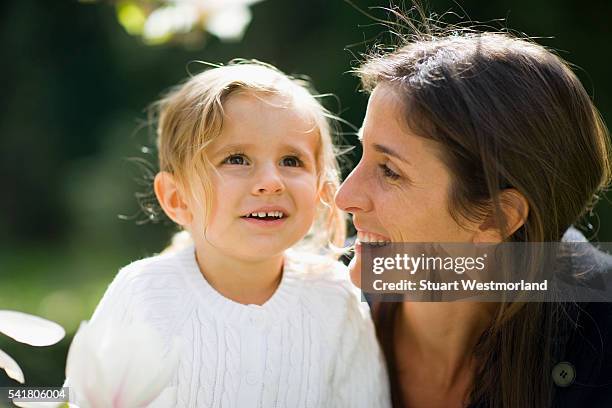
191,94 -> 319,261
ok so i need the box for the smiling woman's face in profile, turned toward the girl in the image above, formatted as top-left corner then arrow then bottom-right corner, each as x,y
336,85 -> 473,283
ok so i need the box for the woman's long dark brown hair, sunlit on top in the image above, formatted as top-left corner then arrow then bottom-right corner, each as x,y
356,24 -> 610,408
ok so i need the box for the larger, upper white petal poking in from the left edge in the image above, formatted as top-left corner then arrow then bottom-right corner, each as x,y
0,310 -> 66,346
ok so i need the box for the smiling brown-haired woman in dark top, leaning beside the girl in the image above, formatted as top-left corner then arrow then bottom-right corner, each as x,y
336,27 -> 612,408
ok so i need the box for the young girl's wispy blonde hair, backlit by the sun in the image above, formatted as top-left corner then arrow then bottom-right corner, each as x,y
151,60 -> 346,252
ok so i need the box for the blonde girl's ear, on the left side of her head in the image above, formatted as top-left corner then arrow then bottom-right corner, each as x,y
153,171 -> 192,227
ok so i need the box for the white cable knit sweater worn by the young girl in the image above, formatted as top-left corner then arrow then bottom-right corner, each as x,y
86,246 -> 390,408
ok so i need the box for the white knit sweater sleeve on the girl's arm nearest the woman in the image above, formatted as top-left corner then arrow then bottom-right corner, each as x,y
330,286 -> 391,408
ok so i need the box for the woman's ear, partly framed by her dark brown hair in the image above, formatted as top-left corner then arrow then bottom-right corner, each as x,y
474,188 -> 529,243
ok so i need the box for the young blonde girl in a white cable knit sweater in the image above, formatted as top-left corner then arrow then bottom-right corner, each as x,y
77,62 -> 388,408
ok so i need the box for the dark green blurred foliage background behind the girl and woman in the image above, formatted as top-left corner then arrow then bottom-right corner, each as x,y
0,0 -> 612,385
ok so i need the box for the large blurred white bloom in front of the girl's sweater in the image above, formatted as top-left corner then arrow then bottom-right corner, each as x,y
66,321 -> 178,408
